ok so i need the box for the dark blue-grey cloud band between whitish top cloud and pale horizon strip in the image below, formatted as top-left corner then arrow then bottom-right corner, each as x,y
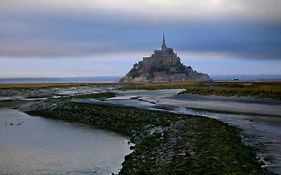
0,11 -> 281,59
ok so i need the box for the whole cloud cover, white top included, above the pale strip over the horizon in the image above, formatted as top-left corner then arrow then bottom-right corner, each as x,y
0,0 -> 281,60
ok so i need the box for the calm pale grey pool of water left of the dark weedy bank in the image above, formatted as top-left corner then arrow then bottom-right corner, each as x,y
0,108 -> 130,175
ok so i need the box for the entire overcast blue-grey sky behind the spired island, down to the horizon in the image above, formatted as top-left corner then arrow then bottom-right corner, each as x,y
0,0 -> 281,77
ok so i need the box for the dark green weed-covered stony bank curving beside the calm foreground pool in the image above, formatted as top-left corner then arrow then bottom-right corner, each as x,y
25,98 -> 265,175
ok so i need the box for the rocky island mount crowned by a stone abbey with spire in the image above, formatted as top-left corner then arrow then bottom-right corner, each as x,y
120,35 -> 210,83
